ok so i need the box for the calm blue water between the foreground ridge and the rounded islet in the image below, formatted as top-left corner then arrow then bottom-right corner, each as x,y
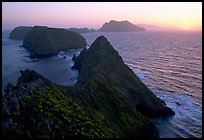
2,31 -> 81,93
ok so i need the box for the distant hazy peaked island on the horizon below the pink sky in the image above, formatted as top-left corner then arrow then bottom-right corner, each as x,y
98,20 -> 145,32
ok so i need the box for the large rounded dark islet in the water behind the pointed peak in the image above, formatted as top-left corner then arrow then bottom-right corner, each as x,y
22,26 -> 86,57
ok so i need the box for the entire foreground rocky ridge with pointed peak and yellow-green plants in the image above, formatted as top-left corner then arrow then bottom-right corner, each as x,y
2,36 -> 175,138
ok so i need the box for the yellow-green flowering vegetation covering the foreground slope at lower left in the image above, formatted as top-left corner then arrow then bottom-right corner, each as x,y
4,85 -> 111,138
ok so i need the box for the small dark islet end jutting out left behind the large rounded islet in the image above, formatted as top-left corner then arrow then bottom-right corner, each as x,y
9,26 -> 32,40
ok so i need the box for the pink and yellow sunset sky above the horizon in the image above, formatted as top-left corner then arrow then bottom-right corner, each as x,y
2,2 -> 202,31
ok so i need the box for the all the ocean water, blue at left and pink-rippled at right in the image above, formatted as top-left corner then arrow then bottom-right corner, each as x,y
2,31 -> 202,138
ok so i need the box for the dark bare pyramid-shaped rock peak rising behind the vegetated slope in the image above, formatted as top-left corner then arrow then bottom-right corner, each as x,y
74,36 -> 175,117
